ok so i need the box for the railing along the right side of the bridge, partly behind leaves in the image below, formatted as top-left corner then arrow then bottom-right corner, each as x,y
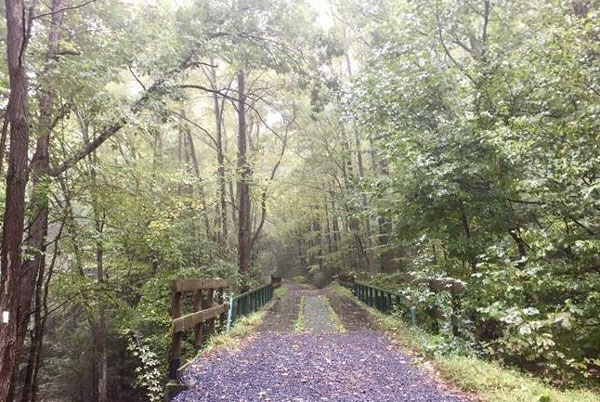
352,279 -> 462,335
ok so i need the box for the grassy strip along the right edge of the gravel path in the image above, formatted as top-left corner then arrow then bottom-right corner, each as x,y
370,304 -> 600,402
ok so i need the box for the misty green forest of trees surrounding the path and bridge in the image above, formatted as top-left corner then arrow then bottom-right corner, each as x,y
0,0 -> 600,402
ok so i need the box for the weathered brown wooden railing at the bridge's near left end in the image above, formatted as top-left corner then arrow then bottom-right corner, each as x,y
169,278 -> 229,380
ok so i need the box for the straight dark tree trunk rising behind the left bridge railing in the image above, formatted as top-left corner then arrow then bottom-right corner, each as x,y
237,70 -> 250,272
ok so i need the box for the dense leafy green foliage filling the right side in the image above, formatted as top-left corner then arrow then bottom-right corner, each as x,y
346,0 -> 600,385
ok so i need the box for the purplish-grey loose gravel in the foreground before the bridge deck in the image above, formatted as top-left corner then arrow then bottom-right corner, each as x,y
174,331 -> 467,402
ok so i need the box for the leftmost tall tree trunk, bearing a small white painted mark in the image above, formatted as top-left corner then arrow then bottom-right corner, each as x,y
0,0 -> 29,401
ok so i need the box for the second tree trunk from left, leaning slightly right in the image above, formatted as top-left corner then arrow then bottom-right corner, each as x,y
16,0 -> 67,401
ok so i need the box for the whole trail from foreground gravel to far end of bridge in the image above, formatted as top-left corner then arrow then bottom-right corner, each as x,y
173,284 -> 471,402
